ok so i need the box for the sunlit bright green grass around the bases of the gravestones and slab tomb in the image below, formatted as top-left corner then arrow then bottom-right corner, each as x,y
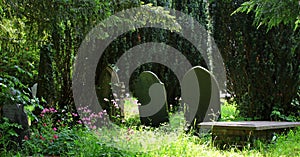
0,100 -> 300,157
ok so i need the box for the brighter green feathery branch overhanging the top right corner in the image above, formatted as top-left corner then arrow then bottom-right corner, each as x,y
233,0 -> 300,30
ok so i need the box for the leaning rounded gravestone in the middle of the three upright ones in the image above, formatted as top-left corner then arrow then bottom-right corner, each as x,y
132,71 -> 169,127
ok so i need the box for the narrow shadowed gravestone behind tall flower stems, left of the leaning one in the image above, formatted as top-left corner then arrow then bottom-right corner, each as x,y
96,67 -> 124,122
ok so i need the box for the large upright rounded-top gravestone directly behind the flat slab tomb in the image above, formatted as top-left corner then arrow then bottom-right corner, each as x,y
181,66 -> 221,130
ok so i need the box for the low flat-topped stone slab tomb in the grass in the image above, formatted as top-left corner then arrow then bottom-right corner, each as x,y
198,121 -> 300,148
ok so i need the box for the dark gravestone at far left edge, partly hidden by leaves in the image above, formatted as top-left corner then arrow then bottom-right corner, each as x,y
2,104 -> 29,147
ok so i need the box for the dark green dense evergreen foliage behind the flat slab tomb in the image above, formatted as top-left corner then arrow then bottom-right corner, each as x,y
211,0 -> 300,120
